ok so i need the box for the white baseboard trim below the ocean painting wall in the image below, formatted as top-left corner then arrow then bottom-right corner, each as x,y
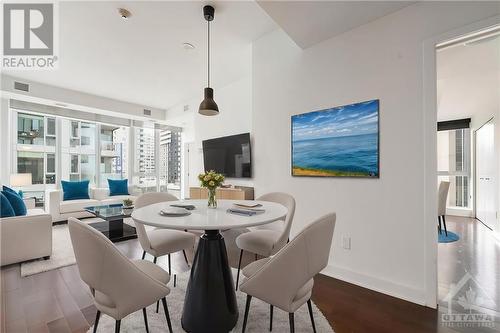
321,265 -> 426,306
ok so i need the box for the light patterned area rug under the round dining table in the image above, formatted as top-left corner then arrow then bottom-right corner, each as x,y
88,271 -> 333,333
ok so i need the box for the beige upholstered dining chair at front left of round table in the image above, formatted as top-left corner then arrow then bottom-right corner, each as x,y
68,217 -> 172,333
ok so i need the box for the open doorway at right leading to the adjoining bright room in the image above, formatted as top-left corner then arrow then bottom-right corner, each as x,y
434,25 -> 500,332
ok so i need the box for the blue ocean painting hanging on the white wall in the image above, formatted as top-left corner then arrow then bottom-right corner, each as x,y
292,100 -> 379,178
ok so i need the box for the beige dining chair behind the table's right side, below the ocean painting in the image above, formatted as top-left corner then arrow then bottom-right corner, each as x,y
236,192 -> 295,290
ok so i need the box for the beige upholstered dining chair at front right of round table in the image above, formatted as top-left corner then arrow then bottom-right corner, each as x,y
240,213 -> 336,333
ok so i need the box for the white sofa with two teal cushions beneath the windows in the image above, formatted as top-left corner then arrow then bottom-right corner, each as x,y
45,185 -> 140,222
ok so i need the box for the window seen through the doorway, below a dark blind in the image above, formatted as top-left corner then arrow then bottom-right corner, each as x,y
438,128 -> 471,208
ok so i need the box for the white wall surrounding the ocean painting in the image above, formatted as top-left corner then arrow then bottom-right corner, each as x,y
252,2 -> 499,306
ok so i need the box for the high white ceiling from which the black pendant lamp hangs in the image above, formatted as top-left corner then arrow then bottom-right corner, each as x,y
6,1 -> 277,108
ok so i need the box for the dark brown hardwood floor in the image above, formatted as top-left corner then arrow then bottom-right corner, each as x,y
0,217 -> 500,333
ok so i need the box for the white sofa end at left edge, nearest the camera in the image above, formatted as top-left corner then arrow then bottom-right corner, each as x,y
0,208 -> 52,266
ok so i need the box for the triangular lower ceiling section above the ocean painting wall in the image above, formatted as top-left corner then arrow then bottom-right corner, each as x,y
258,1 -> 415,49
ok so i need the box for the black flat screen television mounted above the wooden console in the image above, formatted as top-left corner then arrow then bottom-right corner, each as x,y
203,133 -> 252,178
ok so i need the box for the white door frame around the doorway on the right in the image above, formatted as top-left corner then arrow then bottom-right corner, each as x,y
423,15 -> 500,309
